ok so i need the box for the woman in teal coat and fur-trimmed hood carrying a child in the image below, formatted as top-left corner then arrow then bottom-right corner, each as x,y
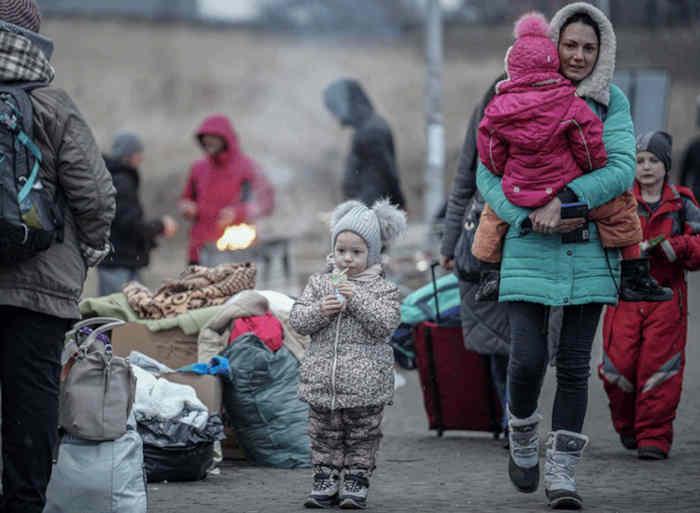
477,2 -> 656,509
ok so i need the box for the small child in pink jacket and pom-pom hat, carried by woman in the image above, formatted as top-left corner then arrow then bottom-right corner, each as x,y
472,13 -> 672,301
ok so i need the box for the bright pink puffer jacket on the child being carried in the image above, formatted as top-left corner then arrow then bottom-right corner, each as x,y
477,71 -> 607,207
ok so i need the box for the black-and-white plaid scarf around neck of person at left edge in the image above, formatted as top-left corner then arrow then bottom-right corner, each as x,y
0,30 -> 56,84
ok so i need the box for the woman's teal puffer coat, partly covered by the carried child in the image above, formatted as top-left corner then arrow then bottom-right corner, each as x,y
477,85 -> 636,306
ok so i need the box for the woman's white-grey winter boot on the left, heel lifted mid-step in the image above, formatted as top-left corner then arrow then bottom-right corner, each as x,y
508,411 -> 542,493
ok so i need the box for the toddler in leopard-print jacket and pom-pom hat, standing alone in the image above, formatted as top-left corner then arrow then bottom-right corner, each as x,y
289,201 -> 406,509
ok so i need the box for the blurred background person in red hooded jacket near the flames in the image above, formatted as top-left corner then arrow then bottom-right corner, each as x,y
180,114 -> 274,264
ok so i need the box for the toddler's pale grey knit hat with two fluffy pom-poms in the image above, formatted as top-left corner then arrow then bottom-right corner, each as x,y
331,200 -> 406,266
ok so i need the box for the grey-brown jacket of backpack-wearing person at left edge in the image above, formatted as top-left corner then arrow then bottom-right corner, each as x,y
0,25 -> 115,319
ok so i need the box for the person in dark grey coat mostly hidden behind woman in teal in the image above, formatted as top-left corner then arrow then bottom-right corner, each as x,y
440,75 -> 510,438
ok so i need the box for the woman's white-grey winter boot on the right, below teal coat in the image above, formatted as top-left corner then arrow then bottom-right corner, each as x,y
544,430 -> 588,509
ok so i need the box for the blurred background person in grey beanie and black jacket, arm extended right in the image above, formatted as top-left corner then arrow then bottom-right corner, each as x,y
97,132 -> 178,296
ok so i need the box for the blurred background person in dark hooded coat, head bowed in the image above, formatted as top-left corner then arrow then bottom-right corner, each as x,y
323,79 -> 406,210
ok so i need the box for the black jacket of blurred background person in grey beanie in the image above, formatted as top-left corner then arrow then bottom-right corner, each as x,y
100,158 -> 163,269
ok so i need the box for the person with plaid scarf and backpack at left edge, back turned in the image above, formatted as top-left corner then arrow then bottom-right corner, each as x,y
0,4 -> 115,513
